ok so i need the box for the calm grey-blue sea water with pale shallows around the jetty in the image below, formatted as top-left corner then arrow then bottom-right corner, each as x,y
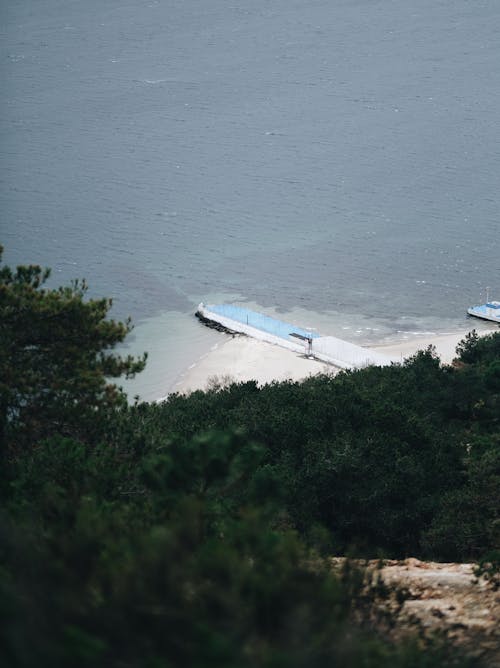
0,0 -> 500,399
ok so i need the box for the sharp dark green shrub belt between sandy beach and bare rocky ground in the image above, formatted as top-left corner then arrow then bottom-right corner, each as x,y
117,335 -> 500,560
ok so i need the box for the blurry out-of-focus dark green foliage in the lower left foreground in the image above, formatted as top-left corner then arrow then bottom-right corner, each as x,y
0,432 -> 476,668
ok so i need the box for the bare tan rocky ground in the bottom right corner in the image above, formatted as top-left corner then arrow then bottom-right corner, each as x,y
344,559 -> 500,668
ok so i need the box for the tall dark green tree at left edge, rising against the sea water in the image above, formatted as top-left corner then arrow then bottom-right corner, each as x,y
0,246 -> 146,449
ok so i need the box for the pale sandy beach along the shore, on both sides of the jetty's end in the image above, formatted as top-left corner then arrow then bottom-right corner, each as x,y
174,329 -> 498,393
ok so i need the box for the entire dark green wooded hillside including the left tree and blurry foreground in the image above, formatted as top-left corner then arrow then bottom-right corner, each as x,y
0,252 -> 500,668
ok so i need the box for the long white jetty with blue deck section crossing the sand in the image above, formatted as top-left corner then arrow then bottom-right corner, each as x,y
196,303 -> 394,369
